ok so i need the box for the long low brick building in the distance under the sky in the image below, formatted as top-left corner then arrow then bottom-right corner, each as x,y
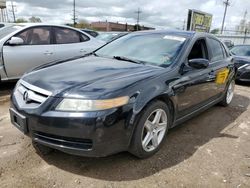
91,21 -> 155,31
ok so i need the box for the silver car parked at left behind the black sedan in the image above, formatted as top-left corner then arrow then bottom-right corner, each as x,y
0,23 -> 105,81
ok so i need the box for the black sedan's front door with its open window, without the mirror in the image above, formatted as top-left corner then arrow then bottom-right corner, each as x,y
174,39 -> 216,118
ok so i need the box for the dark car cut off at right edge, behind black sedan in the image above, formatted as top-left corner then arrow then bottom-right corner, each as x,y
230,45 -> 250,82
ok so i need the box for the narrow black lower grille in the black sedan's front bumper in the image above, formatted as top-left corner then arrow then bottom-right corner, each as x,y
33,132 -> 93,150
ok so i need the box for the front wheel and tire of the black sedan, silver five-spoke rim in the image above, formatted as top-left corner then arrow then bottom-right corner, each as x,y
129,101 -> 171,159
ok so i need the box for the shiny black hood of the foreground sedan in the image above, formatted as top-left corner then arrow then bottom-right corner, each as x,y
22,56 -> 164,98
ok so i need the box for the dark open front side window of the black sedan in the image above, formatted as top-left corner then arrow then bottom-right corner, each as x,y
188,39 -> 208,60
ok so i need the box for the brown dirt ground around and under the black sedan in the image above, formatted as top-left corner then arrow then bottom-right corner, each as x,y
0,83 -> 250,188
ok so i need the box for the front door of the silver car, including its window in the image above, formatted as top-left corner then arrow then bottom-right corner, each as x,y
3,26 -> 55,79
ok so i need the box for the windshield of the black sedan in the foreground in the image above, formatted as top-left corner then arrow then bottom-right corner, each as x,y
96,33 -> 186,66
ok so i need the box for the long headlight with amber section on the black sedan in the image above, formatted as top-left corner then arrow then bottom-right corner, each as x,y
56,96 -> 129,112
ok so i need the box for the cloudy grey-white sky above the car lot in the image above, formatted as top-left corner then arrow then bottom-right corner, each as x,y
7,0 -> 250,29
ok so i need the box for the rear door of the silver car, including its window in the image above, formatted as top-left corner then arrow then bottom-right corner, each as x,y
53,27 -> 98,60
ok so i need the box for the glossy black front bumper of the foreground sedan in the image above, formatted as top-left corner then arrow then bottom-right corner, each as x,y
11,99 -> 133,157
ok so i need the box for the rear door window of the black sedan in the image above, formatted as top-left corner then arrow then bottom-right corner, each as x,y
208,38 -> 224,61
